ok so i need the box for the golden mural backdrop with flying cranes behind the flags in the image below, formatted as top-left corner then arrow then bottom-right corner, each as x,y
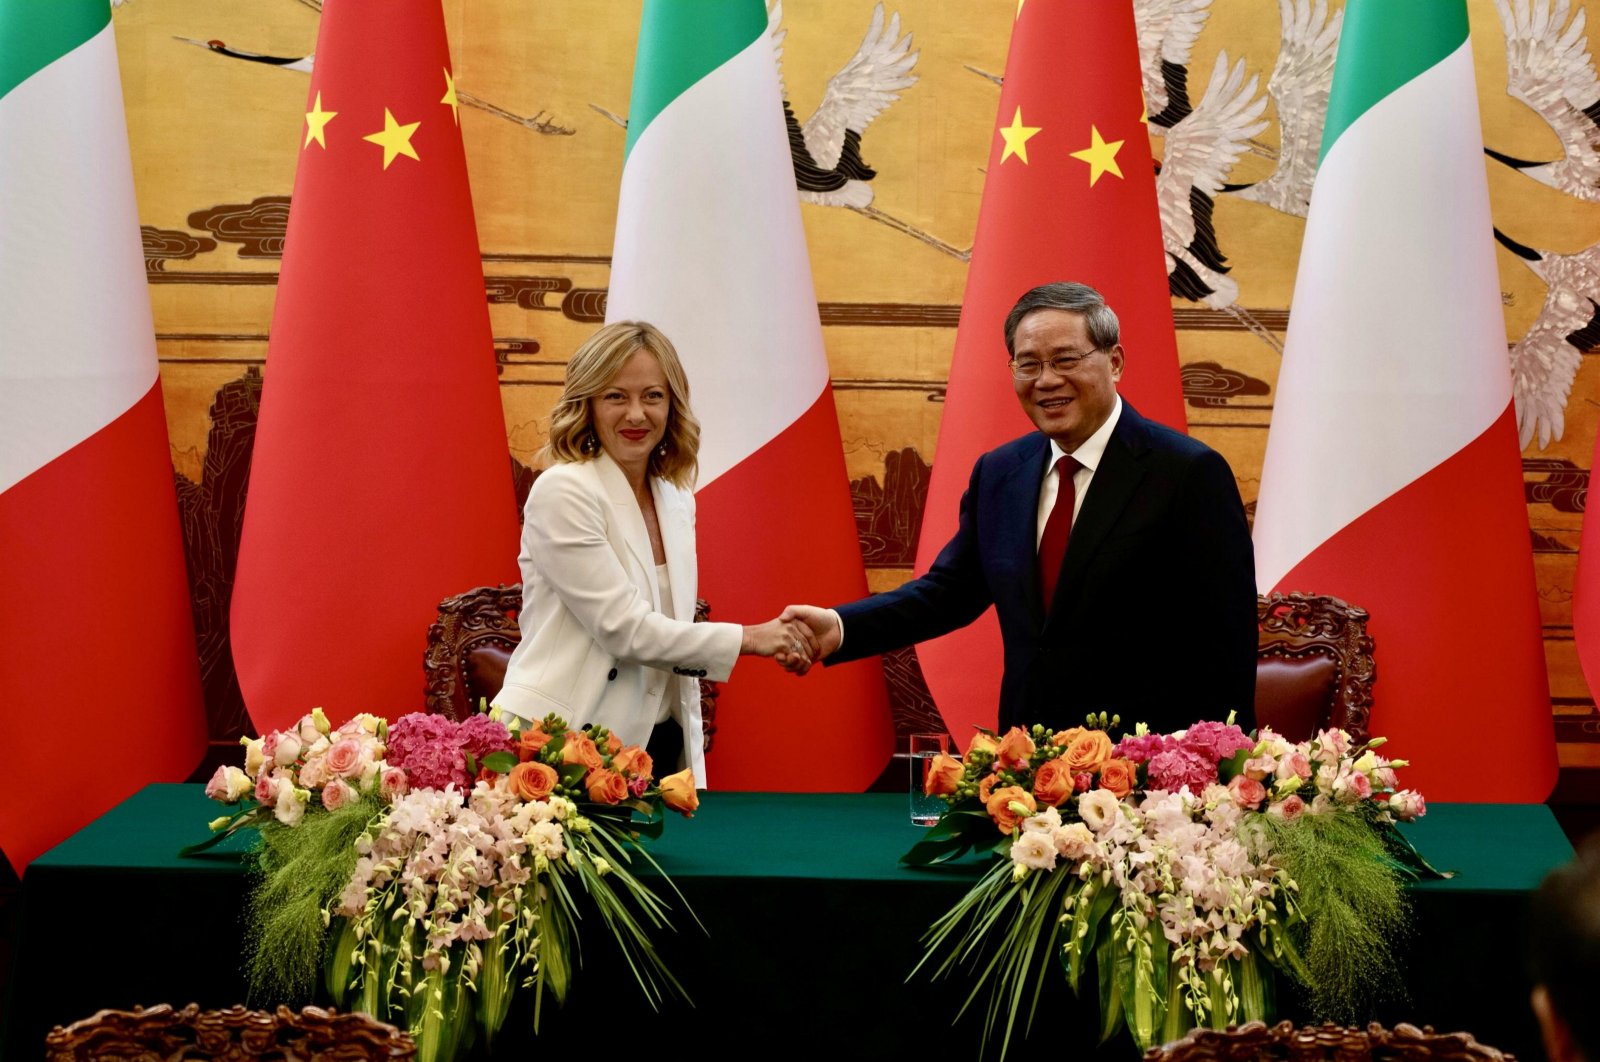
112,0 -> 1600,766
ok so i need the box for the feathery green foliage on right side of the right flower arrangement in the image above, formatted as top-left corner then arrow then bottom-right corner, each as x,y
1254,812 -> 1408,1024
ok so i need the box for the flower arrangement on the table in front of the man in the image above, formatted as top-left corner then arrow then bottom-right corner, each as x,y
904,717 -> 1438,1056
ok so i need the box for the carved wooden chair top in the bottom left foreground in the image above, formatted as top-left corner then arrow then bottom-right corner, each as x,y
45,1003 -> 416,1062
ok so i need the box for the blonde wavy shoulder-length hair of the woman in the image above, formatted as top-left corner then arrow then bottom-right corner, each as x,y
539,321 -> 699,489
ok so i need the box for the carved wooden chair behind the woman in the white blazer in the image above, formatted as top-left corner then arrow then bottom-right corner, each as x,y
422,585 -> 718,752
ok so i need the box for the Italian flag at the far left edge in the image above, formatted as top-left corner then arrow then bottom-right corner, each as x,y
0,0 -> 205,870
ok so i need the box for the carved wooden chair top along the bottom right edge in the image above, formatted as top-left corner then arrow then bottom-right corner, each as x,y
1144,1022 -> 1514,1062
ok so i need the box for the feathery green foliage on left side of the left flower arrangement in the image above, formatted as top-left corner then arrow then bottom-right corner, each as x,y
245,795 -> 381,1006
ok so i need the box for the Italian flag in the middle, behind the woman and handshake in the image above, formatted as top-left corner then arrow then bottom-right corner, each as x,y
606,0 -> 893,790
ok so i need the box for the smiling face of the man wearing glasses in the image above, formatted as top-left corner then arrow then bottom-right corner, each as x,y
1011,310 -> 1122,454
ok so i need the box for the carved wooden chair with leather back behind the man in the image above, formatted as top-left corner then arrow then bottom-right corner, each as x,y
1256,593 -> 1378,741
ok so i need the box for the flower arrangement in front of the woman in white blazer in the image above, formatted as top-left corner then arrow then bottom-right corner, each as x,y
196,709 -> 699,1062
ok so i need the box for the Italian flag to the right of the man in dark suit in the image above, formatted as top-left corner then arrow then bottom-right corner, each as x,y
1254,0 -> 1557,801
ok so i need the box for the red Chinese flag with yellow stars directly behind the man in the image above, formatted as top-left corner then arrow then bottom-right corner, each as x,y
915,0 -> 1186,747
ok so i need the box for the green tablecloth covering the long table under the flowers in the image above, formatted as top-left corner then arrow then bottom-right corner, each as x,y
0,785 -> 1571,1059
